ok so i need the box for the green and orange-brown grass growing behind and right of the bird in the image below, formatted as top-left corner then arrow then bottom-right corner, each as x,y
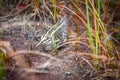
0,0 -> 120,80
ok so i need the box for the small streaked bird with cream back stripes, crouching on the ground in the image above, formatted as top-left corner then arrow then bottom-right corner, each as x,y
35,17 -> 67,50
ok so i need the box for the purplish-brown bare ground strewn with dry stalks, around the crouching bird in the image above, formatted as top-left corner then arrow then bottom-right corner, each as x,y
0,0 -> 120,80
